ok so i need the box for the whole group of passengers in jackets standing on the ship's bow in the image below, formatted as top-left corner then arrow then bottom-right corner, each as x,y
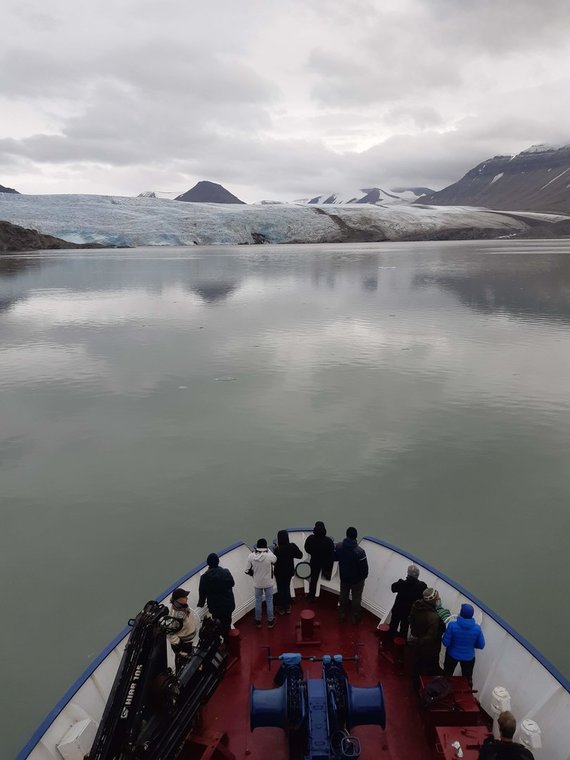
164,521 -> 533,760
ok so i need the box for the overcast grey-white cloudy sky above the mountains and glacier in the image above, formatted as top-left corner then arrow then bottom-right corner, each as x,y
0,0 -> 570,202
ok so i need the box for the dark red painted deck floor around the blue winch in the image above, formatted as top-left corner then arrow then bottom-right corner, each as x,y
197,592 -> 442,760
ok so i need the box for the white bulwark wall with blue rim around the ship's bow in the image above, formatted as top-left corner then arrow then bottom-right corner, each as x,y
17,531 -> 570,760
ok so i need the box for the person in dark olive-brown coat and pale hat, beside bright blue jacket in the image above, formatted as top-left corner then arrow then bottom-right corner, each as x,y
410,588 -> 445,689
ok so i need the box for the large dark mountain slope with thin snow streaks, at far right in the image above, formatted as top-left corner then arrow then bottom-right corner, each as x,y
419,144 -> 570,214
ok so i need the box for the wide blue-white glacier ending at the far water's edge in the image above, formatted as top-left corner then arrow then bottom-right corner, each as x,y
0,193 -> 567,246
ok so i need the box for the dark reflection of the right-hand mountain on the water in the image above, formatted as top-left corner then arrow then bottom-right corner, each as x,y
413,256 -> 570,322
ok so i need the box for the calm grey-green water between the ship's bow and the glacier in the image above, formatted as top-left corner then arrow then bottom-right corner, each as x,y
0,241 -> 570,757
